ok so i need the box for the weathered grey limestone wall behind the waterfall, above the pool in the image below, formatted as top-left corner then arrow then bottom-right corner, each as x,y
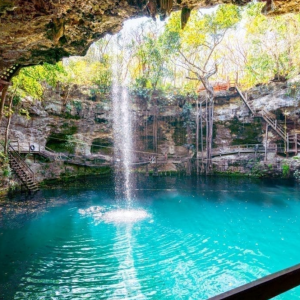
1,79 -> 300,188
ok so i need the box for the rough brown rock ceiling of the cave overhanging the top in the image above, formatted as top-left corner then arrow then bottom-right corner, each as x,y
0,0 -> 300,75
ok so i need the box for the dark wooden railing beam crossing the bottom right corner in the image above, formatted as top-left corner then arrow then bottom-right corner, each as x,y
208,264 -> 300,300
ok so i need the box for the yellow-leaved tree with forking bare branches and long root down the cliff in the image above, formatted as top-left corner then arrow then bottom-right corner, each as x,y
162,5 -> 240,172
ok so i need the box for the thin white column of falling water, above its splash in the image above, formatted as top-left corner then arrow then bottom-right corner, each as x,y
112,39 -> 133,207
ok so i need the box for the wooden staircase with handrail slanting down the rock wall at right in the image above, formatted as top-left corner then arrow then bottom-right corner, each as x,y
235,86 -> 300,154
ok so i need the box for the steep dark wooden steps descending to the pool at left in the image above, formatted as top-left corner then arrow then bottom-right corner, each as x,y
8,145 -> 39,192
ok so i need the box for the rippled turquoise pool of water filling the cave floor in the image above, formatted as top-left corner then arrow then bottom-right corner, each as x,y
0,177 -> 300,300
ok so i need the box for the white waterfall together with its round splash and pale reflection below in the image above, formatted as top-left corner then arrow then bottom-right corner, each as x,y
106,34 -> 148,300
